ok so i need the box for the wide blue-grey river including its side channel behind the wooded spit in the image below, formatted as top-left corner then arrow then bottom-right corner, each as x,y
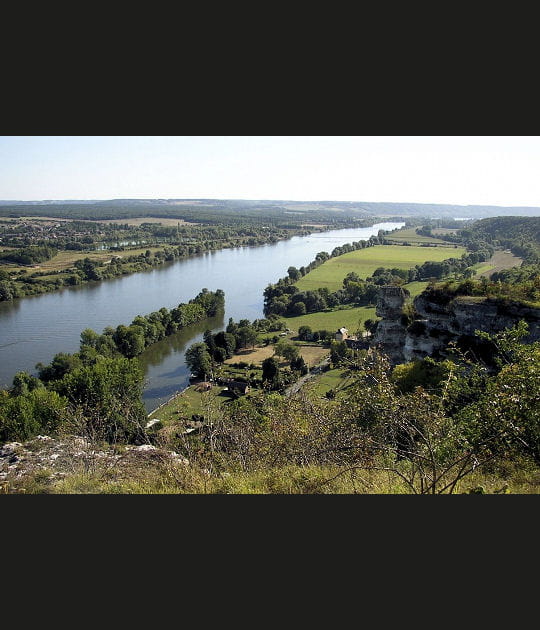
0,222 -> 404,411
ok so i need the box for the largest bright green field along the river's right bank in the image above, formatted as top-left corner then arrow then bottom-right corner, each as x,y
295,245 -> 465,291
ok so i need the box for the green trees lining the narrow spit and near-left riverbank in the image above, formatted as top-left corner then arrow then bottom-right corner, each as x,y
0,289 -> 224,443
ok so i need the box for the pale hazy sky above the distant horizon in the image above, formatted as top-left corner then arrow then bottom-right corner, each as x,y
0,136 -> 540,206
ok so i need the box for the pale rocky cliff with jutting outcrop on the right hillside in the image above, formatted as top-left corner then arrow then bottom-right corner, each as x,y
373,287 -> 540,364
